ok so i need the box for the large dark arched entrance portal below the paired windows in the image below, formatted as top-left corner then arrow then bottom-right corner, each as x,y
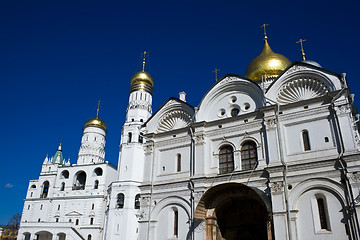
194,183 -> 273,240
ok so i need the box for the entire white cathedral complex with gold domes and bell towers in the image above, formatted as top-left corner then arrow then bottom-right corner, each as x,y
18,36 -> 360,240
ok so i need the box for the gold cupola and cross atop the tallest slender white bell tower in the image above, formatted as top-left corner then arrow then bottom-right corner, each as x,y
130,51 -> 154,94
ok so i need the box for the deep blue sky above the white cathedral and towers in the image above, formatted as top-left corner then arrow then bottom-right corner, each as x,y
0,0 -> 360,224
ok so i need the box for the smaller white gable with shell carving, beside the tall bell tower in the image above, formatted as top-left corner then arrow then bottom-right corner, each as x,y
145,98 -> 195,133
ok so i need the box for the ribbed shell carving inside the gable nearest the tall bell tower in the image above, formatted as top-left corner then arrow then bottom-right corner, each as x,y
157,110 -> 191,133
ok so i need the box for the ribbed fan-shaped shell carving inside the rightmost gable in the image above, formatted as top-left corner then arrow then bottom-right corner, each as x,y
277,78 -> 328,104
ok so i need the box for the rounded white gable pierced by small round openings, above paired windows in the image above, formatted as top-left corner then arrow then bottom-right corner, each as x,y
196,75 -> 265,122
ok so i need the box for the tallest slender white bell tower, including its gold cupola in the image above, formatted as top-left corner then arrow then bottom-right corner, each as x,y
105,52 -> 154,239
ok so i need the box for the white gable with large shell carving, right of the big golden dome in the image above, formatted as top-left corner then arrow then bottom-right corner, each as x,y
266,62 -> 343,105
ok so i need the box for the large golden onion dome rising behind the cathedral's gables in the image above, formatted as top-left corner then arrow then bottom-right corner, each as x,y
245,37 -> 291,81
